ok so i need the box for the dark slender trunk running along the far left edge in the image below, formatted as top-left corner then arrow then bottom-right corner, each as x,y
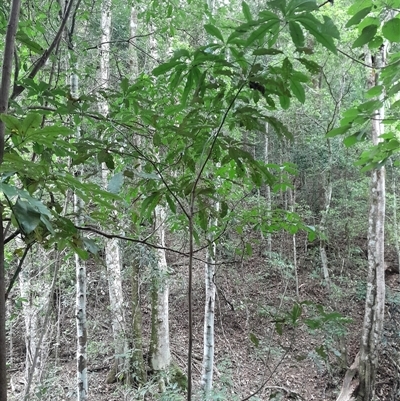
0,0 -> 21,401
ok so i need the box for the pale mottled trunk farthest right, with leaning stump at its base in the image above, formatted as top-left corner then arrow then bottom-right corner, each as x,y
357,46 -> 386,401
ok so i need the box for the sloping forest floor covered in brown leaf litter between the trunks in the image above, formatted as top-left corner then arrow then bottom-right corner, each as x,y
6,230 -> 400,401
